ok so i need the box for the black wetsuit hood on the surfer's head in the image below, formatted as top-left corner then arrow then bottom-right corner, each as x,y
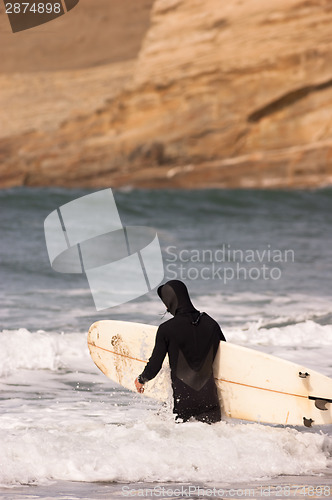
158,280 -> 196,316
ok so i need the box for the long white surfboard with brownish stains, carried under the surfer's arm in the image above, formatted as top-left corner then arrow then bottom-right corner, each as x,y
88,320 -> 332,427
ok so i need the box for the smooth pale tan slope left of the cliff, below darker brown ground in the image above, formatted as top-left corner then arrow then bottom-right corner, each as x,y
0,61 -> 134,141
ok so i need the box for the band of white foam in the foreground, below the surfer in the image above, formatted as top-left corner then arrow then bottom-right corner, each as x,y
0,416 -> 332,485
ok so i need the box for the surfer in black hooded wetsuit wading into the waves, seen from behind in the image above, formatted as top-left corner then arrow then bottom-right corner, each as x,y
135,280 -> 225,424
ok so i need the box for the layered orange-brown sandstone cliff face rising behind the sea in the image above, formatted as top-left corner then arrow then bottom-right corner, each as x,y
0,0 -> 332,187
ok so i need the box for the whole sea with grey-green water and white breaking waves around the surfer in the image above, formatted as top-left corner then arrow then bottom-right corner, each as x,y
0,188 -> 332,500
